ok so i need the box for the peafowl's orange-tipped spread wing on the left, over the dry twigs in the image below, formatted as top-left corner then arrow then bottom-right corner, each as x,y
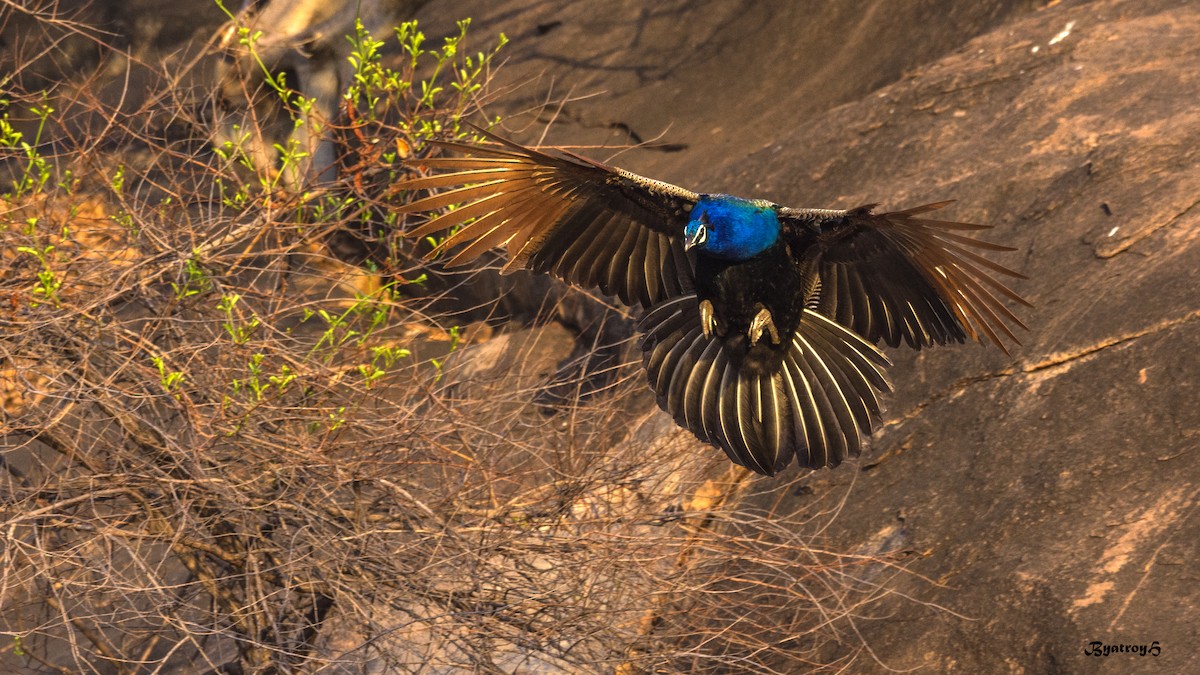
395,130 -> 698,307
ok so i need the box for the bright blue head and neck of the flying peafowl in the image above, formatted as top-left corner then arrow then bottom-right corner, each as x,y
683,195 -> 779,261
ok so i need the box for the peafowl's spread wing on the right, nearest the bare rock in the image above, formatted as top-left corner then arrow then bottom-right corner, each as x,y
780,202 -> 1028,352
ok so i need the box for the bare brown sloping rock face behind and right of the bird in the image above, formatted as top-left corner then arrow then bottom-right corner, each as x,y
420,0 -> 1200,673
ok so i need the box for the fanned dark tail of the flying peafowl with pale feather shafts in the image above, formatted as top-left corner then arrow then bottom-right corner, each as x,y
637,294 -> 890,476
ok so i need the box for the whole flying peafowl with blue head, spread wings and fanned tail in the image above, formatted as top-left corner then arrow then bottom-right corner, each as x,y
397,126 -> 1025,474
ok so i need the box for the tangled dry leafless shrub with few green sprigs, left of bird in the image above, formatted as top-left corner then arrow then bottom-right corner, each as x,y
0,0 -> 926,673
